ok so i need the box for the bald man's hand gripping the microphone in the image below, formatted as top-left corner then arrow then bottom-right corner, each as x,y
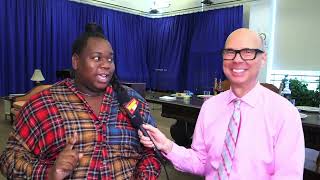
138,124 -> 173,154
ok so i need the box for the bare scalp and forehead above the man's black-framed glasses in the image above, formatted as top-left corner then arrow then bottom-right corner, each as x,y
225,28 -> 264,50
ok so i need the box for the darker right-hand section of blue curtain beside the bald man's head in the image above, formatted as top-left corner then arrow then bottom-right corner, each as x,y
186,7 -> 243,93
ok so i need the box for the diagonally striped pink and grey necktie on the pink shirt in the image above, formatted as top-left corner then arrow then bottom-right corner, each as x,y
214,99 -> 241,180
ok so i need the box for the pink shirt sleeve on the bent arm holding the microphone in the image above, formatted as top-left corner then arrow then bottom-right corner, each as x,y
164,104 -> 207,175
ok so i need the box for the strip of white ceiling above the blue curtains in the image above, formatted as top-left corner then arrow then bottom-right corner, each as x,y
71,0 -> 258,17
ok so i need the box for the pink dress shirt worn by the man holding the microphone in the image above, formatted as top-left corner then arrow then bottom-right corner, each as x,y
165,83 -> 305,180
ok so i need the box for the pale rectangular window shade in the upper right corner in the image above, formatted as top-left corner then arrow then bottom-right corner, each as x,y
272,0 -> 320,71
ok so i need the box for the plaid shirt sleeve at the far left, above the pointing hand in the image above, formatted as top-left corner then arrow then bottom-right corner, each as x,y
0,95 -> 54,179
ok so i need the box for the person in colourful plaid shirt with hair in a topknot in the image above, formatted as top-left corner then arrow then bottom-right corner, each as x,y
0,24 -> 161,179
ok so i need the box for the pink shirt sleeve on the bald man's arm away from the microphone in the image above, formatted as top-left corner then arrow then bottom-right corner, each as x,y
272,106 -> 305,180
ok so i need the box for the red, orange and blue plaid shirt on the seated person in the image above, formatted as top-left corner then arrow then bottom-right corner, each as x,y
0,79 -> 161,179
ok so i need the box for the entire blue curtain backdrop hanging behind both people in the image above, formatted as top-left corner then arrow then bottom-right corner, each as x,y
0,0 -> 243,96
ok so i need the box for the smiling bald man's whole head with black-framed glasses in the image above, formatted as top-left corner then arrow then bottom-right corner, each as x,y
223,28 -> 267,97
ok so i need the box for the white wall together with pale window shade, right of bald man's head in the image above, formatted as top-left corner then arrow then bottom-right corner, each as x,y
249,0 -> 320,82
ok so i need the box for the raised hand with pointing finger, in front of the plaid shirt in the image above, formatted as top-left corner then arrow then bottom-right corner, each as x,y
48,133 -> 83,180
